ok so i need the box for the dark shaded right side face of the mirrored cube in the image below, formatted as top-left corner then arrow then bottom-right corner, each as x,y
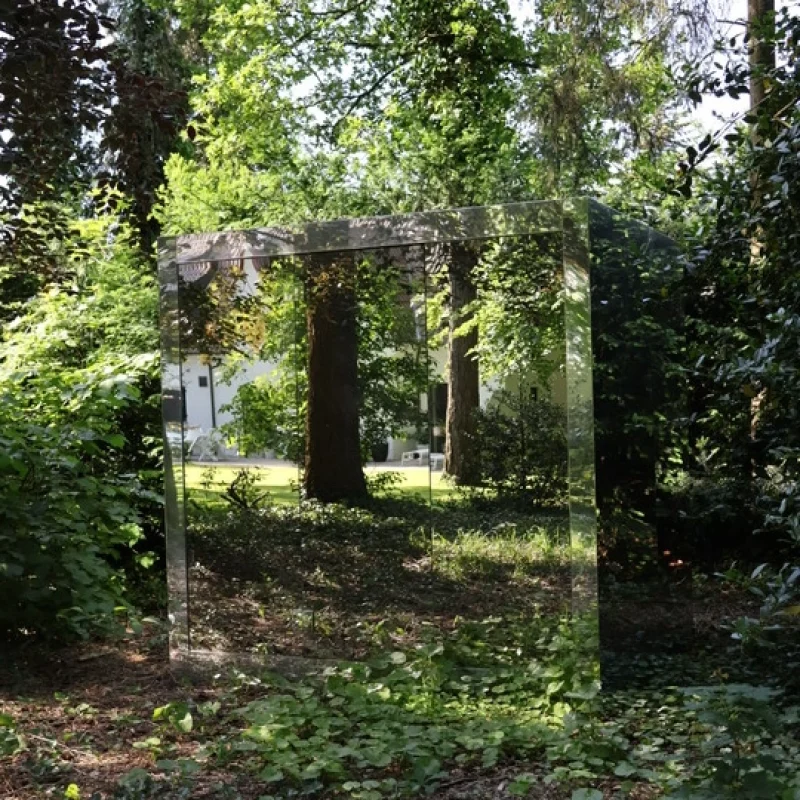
589,203 -> 694,686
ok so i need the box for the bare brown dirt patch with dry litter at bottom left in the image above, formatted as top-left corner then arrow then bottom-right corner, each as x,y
0,635 -> 250,800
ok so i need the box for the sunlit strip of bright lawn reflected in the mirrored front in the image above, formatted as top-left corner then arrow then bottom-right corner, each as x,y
186,464 -> 454,505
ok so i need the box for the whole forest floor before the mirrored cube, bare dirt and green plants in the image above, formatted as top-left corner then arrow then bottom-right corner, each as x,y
0,598 -> 800,800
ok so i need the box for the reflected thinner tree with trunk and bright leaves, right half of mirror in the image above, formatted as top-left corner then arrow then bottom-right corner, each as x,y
428,231 -> 564,485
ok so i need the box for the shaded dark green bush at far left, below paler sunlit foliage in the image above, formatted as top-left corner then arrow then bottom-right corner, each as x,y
0,374 -> 152,633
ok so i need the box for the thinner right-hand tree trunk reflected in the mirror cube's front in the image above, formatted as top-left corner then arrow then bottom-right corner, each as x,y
445,243 -> 480,485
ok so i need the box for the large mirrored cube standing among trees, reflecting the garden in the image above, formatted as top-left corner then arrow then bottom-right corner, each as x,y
159,198 -> 691,677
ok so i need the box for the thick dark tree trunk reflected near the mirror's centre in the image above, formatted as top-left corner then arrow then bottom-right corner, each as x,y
304,254 -> 367,503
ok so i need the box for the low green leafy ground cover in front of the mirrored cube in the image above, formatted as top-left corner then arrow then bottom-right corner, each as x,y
0,618 -> 800,800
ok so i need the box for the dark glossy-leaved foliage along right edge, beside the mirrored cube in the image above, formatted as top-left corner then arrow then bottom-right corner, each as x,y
668,10 -> 800,563
